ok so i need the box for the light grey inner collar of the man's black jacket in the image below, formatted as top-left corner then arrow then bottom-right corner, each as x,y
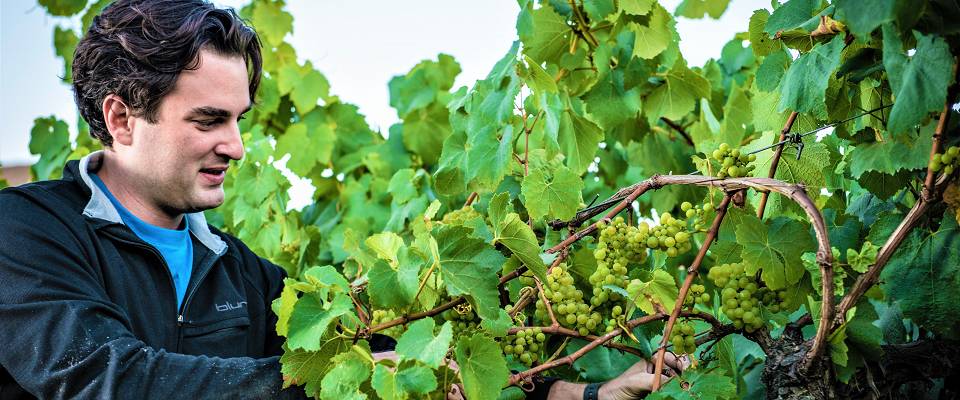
77,150 -> 227,256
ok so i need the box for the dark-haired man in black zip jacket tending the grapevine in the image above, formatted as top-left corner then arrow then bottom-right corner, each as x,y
0,0 -> 688,399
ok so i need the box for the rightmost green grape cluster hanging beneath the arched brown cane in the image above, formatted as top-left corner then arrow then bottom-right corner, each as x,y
707,263 -> 786,332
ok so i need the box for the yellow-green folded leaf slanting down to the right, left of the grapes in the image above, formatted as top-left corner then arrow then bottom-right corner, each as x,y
487,192 -> 547,281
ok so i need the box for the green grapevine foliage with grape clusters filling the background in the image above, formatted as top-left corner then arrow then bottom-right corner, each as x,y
30,0 -> 960,400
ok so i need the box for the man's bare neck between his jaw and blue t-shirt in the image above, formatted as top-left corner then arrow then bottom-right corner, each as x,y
97,149 -> 183,229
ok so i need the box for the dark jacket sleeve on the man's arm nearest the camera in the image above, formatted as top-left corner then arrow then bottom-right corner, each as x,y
0,190 -> 303,399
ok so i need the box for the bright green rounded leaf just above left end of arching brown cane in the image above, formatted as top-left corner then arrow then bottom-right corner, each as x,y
521,166 -> 583,220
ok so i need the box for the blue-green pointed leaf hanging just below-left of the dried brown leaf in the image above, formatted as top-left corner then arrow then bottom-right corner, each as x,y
774,35 -> 843,113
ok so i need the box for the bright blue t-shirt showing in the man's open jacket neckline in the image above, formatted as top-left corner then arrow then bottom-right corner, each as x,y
90,174 -> 193,310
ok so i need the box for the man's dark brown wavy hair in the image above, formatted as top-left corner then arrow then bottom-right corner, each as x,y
73,0 -> 262,146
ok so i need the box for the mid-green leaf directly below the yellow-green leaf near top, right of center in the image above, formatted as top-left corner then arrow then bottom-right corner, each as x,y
643,62 -> 710,121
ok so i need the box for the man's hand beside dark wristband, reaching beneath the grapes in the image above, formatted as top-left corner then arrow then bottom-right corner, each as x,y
597,353 -> 690,400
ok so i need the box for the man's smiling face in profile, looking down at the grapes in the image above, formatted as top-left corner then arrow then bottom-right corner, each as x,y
124,50 -> 250,215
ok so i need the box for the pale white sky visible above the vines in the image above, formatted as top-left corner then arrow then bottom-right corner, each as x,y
0,0 -> 770,166
